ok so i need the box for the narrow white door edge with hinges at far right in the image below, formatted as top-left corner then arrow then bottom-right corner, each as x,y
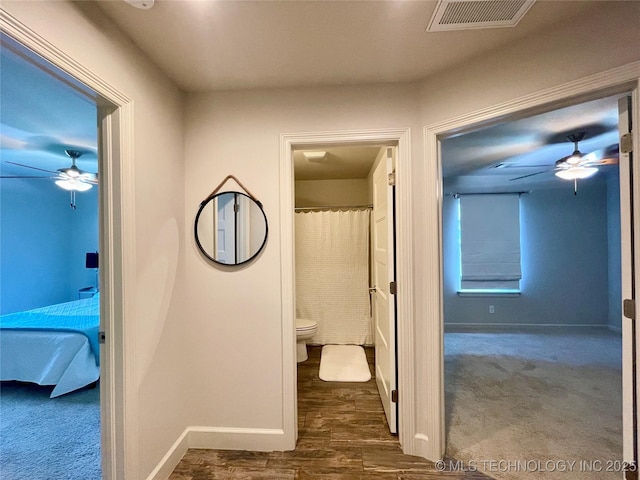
618,97 -> 640,479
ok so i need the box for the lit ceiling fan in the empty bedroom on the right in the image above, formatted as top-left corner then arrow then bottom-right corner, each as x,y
509,132 -> 619,195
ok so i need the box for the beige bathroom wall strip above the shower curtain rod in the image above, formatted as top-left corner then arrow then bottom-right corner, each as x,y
295,178 -> 369,207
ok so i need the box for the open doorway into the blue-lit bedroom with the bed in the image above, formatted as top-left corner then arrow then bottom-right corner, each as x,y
0,34 -> 102,479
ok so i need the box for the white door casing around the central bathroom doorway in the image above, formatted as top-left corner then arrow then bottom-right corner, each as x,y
280,128 -> 415,454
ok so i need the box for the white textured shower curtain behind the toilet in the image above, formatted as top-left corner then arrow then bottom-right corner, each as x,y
295,210 -> 373,345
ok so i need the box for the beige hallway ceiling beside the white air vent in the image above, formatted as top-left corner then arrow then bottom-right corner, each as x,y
91,0 -> 606,91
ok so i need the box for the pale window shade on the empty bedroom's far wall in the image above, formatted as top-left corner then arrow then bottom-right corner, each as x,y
460,194 -> 522,291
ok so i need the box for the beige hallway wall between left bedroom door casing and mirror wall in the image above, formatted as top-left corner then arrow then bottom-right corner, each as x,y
2,1 -> 189,480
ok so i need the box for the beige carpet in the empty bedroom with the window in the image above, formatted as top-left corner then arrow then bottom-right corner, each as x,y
445,334 -> 622,480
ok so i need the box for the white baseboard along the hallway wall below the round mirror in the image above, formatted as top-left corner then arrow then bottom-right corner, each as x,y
147,427 -> 295,480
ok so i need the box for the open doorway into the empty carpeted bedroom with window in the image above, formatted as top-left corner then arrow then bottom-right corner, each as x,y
442,93 -> 627,478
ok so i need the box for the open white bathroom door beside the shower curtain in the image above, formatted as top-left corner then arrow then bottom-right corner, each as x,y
372,147 -> 398,433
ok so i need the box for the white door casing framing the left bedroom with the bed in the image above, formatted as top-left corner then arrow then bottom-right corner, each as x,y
0,19 -> 136,480
